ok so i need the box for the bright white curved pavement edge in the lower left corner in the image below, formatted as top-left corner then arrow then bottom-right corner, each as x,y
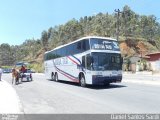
0,80 -> 23,114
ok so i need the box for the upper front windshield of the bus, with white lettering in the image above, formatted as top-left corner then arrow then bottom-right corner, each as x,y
90,38 -> 120,51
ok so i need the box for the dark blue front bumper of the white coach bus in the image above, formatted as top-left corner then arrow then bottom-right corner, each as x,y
92,76 -> 122,85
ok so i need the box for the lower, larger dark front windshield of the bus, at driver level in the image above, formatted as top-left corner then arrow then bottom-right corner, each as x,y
91,52 -> 122,71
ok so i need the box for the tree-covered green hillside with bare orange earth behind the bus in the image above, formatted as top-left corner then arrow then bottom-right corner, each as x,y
0,6 -> 160,71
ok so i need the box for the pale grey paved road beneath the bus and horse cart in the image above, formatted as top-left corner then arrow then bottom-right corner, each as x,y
3,74 -> 160,113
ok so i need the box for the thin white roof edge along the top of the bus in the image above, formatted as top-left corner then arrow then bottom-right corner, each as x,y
45,36 -> 117,53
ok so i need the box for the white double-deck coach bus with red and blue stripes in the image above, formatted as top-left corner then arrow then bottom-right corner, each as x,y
44,36 -> 123,87
